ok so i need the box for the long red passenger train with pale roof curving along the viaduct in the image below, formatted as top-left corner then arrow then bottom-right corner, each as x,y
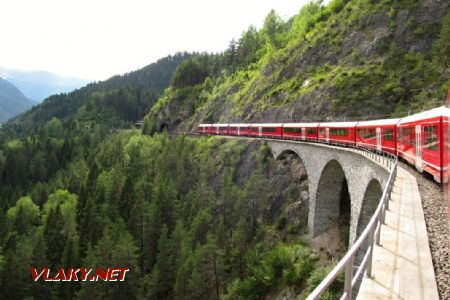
197,106 -> 450,183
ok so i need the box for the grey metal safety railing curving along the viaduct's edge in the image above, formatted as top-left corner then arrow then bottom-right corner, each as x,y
181,133 -> 398,300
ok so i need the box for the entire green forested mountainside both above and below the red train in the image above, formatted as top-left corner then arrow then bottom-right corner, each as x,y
0,0 -> 450,299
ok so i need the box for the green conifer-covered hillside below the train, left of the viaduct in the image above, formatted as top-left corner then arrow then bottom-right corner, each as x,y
0,128 -> 342,299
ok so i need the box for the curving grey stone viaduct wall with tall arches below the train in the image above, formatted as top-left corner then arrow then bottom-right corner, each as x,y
266,140 -> 390,245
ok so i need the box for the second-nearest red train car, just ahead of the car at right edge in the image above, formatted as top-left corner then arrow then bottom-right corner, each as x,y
356,119 -> 400,155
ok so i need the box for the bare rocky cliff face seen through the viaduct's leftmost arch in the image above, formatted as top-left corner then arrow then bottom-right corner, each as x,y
211,140 -> 309,234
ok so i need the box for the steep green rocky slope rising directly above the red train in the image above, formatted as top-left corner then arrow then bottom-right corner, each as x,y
145,0 -> 450,133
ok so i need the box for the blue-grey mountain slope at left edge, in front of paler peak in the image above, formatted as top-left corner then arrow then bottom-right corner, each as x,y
0,77 -> 37,123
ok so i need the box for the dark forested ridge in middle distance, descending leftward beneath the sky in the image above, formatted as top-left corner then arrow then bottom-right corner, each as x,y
10,53 -> 190,132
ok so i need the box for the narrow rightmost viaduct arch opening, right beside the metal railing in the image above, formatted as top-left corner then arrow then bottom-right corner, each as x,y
355,178 -> 383,241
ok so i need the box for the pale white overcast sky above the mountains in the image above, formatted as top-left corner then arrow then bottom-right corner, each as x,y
0,0 -> 320,80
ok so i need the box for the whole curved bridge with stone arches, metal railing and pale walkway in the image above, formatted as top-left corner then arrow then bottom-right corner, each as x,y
190,136 -> 438,300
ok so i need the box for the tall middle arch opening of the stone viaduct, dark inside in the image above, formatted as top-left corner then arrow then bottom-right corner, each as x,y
312,159 -> 351,243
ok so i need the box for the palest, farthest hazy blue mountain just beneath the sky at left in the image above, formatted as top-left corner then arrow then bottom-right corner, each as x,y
0,67 -> 90,102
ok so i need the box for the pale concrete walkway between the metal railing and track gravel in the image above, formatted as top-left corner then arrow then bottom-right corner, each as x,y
357,167 -> 439,300
